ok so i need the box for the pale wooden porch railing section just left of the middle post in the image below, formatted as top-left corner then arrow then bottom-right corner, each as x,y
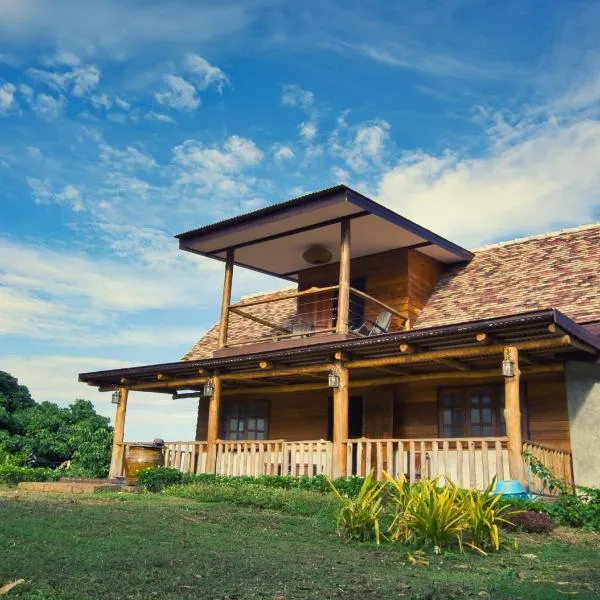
216,440 -> 332,477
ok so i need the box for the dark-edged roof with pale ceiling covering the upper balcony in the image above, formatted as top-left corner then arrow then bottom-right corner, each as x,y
176,185 -> 473,281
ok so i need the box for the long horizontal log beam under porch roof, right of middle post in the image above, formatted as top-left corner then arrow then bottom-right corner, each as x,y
346,335 -> 571,369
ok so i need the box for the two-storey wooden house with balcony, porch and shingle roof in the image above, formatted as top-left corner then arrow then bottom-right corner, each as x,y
79,185 -> 600,487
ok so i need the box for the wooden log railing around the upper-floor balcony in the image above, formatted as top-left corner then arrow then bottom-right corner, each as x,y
226,285 -> 408,347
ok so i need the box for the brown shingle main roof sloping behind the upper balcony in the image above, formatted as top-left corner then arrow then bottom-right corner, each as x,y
183,223 -> 600,360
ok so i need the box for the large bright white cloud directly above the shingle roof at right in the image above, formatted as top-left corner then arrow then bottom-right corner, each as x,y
378,117 -> 600,246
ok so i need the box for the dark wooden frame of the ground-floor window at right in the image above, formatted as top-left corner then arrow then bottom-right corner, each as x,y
436,382 -> 529,439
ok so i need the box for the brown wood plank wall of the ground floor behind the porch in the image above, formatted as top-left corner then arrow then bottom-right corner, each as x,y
196,373 -> 570,449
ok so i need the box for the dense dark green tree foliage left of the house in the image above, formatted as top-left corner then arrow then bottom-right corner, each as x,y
0,371 -> 112,477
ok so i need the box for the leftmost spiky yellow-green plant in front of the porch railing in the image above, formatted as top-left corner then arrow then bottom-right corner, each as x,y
329,470 -> 385,544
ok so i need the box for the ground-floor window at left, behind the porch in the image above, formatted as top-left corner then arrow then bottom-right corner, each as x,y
220,400 -> 269,440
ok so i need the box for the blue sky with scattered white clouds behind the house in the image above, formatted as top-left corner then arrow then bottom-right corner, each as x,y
0,0 -> 600,440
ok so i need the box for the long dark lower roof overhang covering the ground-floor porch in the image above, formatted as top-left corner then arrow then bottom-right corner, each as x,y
79,309 -> 600,393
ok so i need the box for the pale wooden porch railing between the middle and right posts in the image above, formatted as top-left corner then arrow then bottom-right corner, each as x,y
346,437 -> 510,489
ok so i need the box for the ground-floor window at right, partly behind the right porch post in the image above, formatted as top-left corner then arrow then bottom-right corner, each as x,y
439,385 -> 527,438
